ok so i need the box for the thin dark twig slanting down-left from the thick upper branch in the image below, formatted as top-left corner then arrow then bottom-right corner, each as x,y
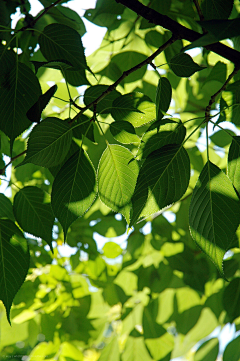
69,35 -> 179,124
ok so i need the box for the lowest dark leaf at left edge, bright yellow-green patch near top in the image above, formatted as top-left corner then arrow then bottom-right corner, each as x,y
0,219 -> 30,323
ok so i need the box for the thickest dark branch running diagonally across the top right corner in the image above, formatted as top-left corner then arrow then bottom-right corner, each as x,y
115,0 -> 240,65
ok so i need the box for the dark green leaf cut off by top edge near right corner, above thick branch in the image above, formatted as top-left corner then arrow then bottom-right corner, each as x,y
201,0 -> 234,20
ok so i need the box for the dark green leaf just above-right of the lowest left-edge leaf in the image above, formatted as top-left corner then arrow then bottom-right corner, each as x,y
13,186 -> 54,249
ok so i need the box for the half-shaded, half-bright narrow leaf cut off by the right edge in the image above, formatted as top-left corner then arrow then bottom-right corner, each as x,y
227,136 -> 240,194
